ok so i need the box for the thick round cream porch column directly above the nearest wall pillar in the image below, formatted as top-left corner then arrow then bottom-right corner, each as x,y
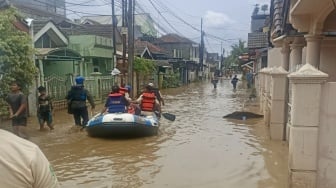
305,35 -> 323,69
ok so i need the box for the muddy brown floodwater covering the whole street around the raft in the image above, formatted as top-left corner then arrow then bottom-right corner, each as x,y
14,80 -> 288,188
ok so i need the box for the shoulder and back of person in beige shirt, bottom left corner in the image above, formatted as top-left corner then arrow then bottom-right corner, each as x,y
0,129 -> 60,188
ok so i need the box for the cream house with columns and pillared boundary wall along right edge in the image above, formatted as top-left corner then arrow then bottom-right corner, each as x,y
259,0 -> 336,188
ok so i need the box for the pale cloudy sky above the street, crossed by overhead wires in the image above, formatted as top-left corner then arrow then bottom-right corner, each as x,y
67,0 -> 270,53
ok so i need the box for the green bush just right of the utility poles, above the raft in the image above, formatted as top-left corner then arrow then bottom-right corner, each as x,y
133,57 -> 156,75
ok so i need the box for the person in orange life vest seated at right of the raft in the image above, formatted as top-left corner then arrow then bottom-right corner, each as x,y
134,85 -> 161,117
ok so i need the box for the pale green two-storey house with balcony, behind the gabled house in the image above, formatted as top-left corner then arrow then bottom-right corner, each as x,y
58,21 -> 122,76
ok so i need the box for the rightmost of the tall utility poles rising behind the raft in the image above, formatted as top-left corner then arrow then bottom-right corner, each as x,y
128,0 -> 135,97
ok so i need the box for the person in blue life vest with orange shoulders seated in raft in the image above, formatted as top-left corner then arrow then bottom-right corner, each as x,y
101,85 -> 129,114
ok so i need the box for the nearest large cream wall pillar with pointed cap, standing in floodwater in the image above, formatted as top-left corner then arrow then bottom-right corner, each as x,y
288,64 -> 328,188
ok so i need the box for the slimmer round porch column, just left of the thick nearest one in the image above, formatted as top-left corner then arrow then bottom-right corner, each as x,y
289,37 -> 305,72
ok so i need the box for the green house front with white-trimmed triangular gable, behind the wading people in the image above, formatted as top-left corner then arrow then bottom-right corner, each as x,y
31,20 -> 84,100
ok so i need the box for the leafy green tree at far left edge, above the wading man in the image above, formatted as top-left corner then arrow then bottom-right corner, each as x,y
0,8 -> 37,116
